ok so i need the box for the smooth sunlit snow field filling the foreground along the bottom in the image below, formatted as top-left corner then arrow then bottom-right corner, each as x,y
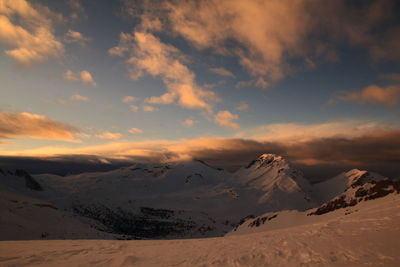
0,194 -> 400,266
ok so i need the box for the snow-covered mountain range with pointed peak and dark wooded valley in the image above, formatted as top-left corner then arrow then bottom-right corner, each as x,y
0,154 -> 398,242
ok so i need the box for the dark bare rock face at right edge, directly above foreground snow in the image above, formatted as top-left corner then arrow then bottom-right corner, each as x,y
307,179 -> 400,216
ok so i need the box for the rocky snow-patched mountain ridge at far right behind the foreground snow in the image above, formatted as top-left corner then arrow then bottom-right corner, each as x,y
228,169 -> 400,235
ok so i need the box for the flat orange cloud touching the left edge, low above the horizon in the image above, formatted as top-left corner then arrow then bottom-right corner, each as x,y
0,112 -> 78,142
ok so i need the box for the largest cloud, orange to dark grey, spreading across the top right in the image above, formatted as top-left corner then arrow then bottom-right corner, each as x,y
125,0 -> 400,88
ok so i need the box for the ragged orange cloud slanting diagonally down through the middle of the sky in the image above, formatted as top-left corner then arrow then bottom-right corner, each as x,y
109,31 -> 218,111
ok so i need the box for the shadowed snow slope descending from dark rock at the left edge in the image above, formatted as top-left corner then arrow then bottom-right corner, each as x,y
0,170 -> 116,240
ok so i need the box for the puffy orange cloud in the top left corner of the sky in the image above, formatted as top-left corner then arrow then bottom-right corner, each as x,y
0,0 -> 64,65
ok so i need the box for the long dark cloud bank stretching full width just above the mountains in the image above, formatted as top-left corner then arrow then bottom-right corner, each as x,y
0,130 -> 400,181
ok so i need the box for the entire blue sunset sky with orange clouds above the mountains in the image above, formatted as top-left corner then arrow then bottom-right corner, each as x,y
0,0 -> 400,180
